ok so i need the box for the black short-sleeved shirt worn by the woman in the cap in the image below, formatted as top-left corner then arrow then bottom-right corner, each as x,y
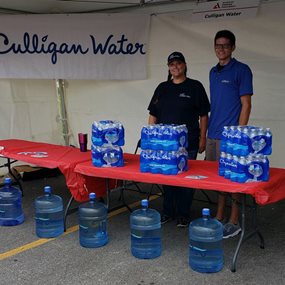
148,78 -> 210,150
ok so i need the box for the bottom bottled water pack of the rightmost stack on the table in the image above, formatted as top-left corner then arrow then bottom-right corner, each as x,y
219,152 -> 269,183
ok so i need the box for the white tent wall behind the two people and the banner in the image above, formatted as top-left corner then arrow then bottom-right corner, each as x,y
0,1 -> 285,167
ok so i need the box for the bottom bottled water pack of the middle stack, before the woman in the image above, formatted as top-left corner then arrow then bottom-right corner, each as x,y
140,148 -> 188,175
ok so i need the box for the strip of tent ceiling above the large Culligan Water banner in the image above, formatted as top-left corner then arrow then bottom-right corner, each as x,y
0,0 -> 200,14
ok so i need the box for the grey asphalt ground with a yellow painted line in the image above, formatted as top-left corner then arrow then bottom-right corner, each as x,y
0,173 -> 285,285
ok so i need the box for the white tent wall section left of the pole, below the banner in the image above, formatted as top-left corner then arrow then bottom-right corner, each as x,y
0,79 -> 61,143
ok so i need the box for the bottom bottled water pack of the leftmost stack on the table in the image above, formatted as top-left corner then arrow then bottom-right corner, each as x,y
91,144 -> 124,167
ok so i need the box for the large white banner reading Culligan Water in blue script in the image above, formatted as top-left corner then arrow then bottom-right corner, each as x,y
0,14 -> 150,80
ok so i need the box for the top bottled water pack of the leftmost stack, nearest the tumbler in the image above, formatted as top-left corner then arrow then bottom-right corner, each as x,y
92,120 -> 125,146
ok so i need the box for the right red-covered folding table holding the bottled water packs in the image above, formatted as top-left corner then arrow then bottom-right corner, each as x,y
74,153 -> 285,272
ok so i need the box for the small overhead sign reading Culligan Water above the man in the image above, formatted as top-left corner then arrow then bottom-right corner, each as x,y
192,0 -> 260,21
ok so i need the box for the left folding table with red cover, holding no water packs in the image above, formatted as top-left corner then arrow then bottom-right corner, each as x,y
0,139 -> 113,230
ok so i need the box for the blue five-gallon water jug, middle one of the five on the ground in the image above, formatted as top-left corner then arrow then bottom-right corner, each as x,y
78,193 -> 109,247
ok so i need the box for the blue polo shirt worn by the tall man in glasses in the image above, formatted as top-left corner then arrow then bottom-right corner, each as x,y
208,58 -> 253,139
